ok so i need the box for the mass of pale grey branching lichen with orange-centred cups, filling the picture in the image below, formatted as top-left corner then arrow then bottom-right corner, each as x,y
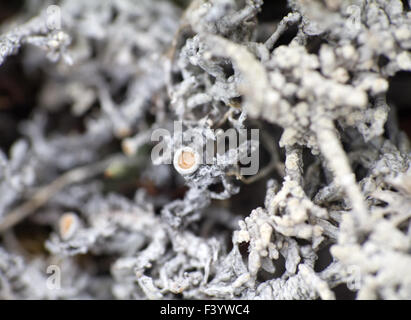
0,0 -> 411,300
